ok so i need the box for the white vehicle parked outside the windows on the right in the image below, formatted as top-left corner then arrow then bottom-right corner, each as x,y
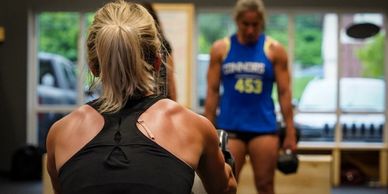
294,78 -> 385,142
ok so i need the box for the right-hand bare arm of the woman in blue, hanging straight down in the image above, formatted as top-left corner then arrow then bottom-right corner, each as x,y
271,43 -> 296,151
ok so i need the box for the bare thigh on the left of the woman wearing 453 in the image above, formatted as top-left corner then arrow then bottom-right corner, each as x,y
228,138 -> 247,181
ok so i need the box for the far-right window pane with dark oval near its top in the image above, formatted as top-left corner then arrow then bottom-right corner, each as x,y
340,13 -> 385,142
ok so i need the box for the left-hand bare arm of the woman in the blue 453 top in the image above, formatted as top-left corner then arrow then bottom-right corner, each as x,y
205,40 -> 226,124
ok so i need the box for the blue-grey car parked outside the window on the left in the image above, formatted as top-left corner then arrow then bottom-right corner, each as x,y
37,52 -> 98,148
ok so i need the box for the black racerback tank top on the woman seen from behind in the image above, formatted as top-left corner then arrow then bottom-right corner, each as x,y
59,96 -> 194,194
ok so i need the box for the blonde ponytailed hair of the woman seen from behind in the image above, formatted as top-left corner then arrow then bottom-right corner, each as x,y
87,0 -> 161,113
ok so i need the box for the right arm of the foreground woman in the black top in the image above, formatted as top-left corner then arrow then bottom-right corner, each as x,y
197,117 -> 237,194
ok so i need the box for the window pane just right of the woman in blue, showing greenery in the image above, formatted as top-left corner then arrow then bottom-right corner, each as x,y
292,13 -> 338,141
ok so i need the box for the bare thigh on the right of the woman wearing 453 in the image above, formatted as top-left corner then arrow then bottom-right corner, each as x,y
248,135 -> 279,194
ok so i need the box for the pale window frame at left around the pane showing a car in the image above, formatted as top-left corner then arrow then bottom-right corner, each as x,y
26,10 -> 90,145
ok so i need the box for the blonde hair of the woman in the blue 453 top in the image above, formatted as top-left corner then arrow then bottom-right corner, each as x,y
233,0 -> 266,30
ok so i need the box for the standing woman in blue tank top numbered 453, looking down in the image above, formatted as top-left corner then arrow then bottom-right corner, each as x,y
205,0 -> 296,194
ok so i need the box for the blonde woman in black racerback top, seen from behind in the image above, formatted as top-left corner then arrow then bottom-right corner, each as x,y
46,0 -> 237,194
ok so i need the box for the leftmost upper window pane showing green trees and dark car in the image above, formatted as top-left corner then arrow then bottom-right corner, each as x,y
37,12 -> 79,104
